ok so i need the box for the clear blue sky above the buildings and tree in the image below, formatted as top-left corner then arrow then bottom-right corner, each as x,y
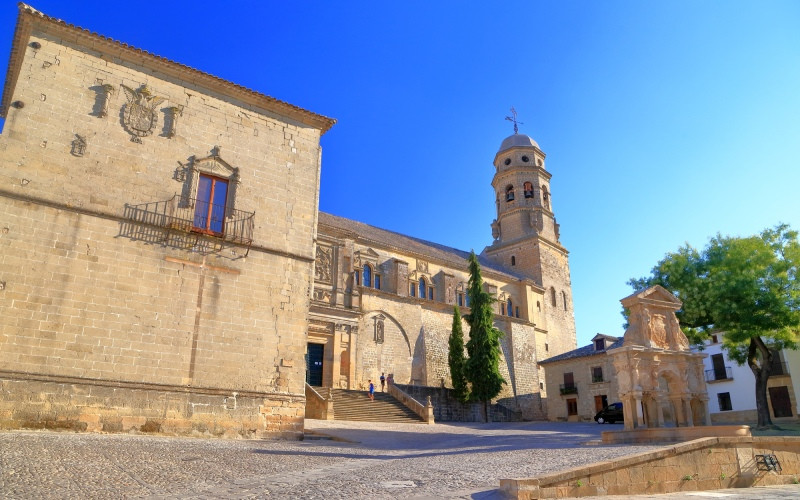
0,0 -> 800,345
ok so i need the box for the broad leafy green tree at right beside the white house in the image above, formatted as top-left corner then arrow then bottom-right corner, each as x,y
628,225 -> 800,428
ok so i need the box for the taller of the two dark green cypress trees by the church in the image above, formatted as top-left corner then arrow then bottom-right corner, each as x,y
464,252 -> 506,422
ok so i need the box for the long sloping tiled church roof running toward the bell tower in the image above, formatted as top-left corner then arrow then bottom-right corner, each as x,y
319,212 -> 530,280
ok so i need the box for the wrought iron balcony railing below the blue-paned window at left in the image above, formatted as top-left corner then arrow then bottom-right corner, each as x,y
125,194 -> 255,246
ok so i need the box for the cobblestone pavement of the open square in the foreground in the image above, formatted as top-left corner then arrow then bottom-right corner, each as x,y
0,420 -> 800,500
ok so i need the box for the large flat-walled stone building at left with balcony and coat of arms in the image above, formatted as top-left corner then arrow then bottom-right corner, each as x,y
0,5 -> 334,436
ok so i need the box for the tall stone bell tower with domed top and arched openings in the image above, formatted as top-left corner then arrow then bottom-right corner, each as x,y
483,130 -> 576,357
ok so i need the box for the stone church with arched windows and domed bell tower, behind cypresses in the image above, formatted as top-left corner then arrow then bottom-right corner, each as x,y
308,133 -> 575,418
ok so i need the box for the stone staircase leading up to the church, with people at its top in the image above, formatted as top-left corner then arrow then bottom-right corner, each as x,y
333,389 -> 422,424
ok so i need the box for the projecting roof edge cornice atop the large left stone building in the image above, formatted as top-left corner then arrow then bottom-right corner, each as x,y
0,3 -> 336,135
